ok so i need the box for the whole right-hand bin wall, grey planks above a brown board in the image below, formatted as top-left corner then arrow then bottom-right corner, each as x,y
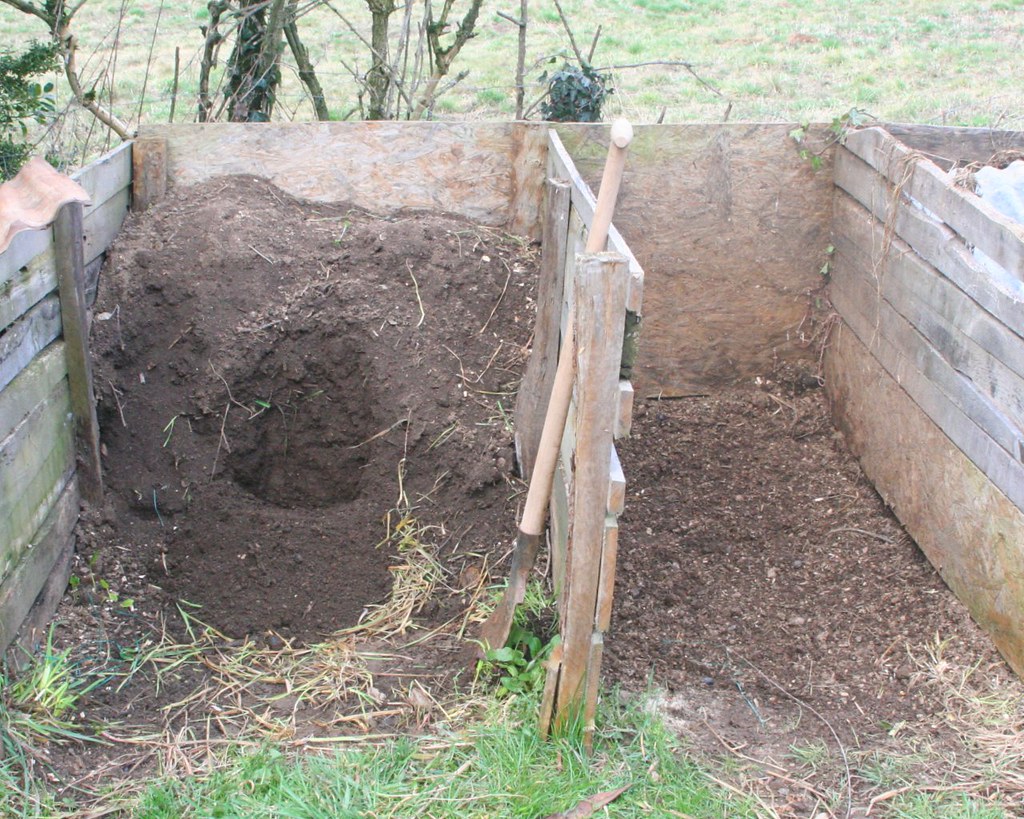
826,128 -> 1024,674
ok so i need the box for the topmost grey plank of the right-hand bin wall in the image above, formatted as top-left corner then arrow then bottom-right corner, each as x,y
846,128 -> 1024,278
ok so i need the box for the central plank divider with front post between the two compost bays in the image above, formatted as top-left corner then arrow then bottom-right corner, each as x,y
516,128 -> 644,741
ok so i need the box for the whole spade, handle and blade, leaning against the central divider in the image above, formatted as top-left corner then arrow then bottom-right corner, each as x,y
480,120 -> 633,650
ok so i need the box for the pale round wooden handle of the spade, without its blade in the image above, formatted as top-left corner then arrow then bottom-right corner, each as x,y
519,120 -> 633,535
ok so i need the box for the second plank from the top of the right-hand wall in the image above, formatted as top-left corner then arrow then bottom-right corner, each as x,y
836,148 -> 1024,335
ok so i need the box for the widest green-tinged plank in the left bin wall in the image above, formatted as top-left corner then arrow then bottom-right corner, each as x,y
0,381 -> 75,580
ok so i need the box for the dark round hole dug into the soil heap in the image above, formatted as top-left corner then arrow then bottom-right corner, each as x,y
228,336 -> 376,509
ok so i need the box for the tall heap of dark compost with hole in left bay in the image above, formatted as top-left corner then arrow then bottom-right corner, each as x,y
90,177 -> 536,640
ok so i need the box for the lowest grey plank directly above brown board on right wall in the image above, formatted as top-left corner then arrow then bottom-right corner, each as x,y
833,239 -> 1024,508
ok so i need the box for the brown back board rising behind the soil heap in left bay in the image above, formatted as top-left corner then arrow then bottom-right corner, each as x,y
139,122 -> 546,238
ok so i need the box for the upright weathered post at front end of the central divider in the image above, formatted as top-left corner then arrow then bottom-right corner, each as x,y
555,253 -> 628,730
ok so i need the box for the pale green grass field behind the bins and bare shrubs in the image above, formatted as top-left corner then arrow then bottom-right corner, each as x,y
0,0 -> 1024,143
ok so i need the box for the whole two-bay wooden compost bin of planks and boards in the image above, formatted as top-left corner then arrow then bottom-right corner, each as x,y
0,123 -> 1024,690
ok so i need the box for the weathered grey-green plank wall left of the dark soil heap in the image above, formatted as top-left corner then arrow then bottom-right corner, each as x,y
0,144 -> 131,651
